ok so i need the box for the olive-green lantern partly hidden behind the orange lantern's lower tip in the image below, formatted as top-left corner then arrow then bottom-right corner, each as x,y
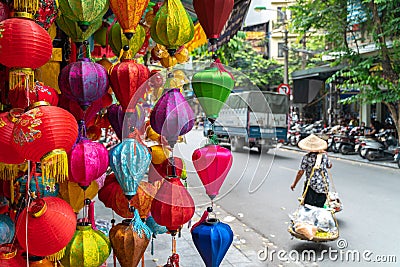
108,22 -> 146,56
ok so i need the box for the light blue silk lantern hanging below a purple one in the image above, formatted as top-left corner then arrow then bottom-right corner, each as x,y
110,138 -> 151,199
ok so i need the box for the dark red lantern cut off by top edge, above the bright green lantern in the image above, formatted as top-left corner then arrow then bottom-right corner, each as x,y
193,0 -> 234,45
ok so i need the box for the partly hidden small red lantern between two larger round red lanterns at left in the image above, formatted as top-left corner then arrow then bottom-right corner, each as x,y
8,81 -> 58,109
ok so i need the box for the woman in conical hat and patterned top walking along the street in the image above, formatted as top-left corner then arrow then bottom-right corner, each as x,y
290,134 -> 332,208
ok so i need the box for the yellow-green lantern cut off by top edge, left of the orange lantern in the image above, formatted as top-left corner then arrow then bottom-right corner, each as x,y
58,0 -> 108,32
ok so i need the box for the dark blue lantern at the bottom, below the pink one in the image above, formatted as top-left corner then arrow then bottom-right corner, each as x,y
192,219 -> 233,267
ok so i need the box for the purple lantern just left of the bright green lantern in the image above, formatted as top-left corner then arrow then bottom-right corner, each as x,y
150,88 -> 194,147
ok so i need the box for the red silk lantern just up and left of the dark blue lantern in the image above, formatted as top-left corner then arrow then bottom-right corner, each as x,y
151,178 -> 194,235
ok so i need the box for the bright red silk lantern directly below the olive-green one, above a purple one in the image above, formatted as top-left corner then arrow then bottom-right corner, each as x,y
110,56 -> 150,111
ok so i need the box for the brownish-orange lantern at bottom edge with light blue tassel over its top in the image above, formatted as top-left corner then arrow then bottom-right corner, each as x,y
109,210 -> 151,267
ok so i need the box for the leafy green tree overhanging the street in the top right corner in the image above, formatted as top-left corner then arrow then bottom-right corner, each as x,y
292,0 -> 400,133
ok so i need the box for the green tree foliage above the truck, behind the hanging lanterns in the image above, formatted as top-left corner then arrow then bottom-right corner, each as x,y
192,32 -> 283,90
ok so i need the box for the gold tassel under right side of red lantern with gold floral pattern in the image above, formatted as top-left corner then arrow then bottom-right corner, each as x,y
41,149 -> 68,184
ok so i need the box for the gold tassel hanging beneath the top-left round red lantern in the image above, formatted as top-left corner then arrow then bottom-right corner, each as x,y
9,68 -> 35,96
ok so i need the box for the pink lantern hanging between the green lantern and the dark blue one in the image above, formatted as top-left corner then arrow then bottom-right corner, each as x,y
192,145 -> 233,200
